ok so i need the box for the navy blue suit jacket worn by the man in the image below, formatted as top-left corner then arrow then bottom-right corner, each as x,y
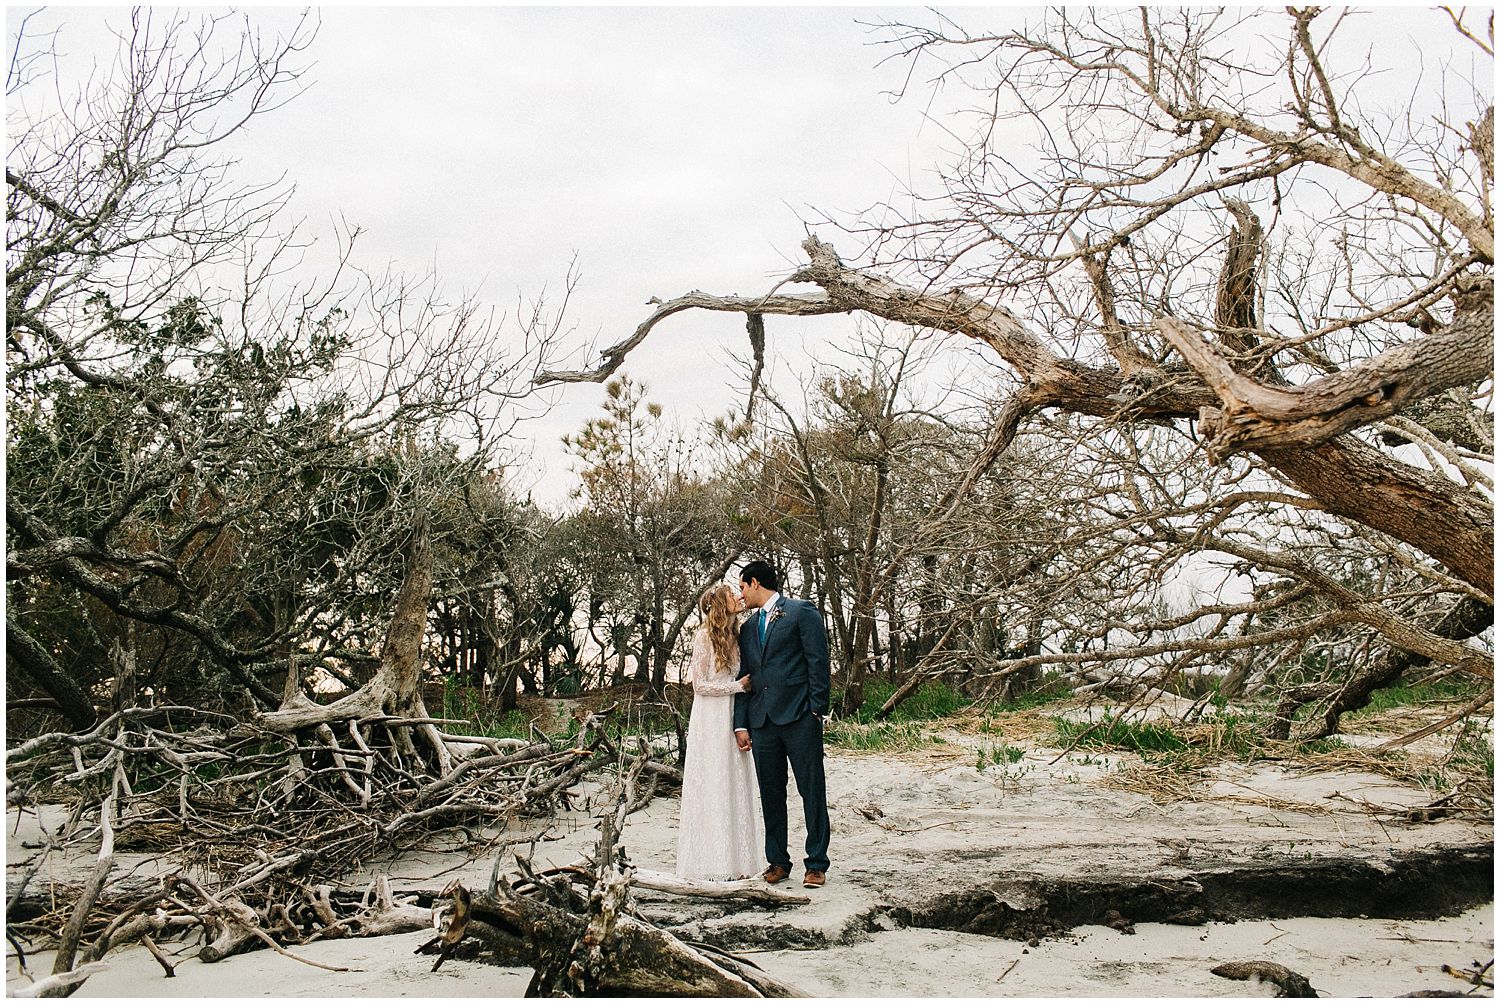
735,596 -> 828,729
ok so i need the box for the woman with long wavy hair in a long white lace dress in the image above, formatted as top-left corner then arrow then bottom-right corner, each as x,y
677,585 -> 765,879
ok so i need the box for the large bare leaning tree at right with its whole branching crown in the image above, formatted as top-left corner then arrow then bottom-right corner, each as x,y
539,9 -> 1494,729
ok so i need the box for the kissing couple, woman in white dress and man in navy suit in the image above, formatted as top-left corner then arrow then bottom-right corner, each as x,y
677,561 -> 828,888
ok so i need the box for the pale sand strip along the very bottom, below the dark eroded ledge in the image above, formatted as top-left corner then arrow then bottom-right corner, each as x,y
11,906 -> 1494,998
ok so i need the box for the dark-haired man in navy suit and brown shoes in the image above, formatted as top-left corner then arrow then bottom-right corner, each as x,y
735,561 -> 828,888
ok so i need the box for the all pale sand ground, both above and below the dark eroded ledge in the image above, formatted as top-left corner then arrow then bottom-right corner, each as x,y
8,735 -> 1494,998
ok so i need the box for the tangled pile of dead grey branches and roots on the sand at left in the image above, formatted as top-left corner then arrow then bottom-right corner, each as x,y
8,707 -> 681,995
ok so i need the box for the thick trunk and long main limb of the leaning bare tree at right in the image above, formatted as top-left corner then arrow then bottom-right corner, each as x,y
537,237 -> 1494,597
